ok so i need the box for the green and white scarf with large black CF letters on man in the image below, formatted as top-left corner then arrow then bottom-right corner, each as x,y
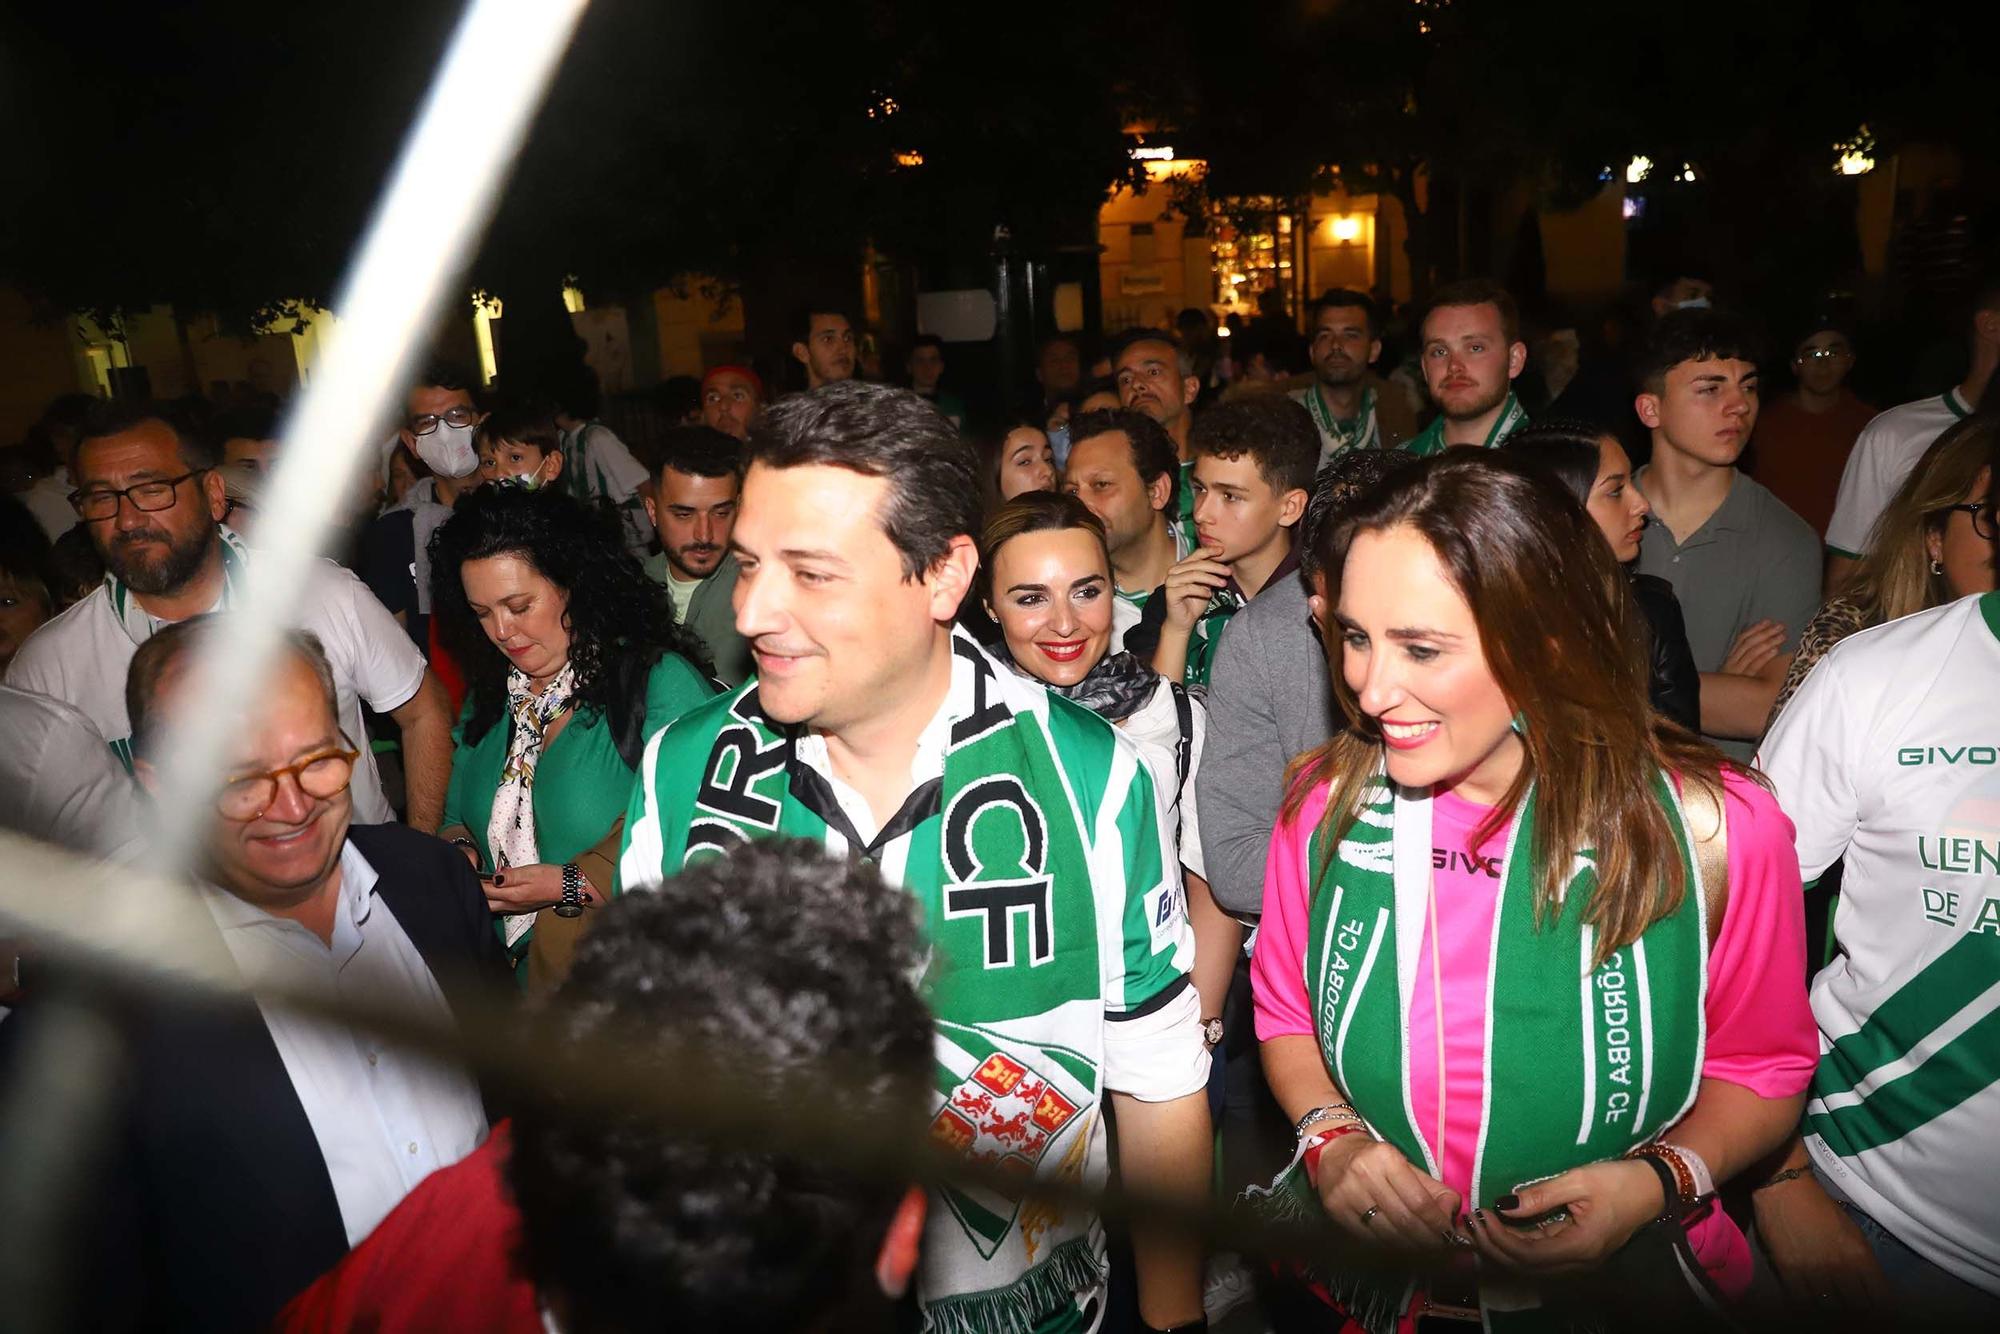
624,632 -> 1152,1334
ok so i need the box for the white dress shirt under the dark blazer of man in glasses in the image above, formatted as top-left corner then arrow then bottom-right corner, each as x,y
202,842 -> 486,1246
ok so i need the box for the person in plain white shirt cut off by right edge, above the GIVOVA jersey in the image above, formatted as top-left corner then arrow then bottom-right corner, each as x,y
1826,276 -> 2000,590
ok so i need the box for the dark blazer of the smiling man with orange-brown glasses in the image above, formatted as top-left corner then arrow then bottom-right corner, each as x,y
0,824 -> 514,1330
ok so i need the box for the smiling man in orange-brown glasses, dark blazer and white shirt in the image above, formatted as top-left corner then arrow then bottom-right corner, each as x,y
0,616 -> 512,1330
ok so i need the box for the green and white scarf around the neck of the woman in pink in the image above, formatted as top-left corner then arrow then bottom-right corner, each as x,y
1252,774 -> 1708,1330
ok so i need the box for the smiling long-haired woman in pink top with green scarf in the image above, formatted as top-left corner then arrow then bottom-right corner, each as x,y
1252,450 -> 1818,1330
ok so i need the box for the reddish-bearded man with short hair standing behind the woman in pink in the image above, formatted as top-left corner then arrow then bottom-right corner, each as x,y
1402,278 -> 1528,456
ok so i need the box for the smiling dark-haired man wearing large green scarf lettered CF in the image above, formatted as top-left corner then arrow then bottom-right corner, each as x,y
620,382 -> 1208,1334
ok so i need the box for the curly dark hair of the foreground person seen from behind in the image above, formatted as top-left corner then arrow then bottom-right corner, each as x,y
508,840 -> 932,1334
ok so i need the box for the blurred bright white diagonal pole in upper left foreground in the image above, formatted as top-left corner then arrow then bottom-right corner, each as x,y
156,0 -> 588,874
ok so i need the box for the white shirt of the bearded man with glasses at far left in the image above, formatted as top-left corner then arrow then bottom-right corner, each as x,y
6,552 -> 424,824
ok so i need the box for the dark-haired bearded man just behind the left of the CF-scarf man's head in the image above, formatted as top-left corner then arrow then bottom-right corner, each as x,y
646,426 -> 756,688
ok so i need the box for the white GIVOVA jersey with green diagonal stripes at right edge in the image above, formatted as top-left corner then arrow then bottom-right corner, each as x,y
1758,594 -> 2000,1294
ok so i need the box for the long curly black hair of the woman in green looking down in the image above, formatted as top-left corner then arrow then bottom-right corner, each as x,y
430,486 -> 714,766
